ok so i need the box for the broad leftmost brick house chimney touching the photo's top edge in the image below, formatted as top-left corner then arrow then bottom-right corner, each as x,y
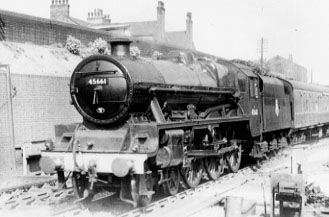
50,0 -> 70,22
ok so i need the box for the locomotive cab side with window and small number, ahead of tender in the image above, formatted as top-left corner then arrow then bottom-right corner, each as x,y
249,77 -> 262,136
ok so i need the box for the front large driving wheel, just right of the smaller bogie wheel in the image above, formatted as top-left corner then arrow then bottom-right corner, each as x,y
181,159 -> 203,188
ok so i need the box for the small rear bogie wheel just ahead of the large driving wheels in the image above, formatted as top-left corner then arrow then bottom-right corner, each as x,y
163,167 -> 180,196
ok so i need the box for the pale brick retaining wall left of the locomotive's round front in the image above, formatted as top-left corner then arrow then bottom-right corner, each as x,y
0,74 -> 82,175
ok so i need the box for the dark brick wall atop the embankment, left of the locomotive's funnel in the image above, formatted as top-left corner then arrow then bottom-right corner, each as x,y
0,10 -> 110,45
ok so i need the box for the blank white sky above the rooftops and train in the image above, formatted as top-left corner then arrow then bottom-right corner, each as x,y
0,0 -> 329,85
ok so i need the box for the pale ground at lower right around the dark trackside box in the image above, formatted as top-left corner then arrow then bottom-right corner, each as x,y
189,138 -> 329,217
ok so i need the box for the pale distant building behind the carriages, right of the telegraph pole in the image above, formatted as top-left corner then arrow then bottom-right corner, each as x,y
266,55 -> 308,82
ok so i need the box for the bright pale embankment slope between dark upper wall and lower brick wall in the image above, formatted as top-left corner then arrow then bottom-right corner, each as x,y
0,41 -> 81,76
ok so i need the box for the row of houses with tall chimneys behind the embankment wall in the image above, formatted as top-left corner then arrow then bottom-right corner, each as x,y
50,0 -> 195,49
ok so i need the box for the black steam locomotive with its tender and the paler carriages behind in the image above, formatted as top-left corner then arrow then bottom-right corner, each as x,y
40,40 -> 329,206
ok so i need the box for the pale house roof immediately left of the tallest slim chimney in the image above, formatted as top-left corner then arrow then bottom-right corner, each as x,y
122,21 -> 157,36
